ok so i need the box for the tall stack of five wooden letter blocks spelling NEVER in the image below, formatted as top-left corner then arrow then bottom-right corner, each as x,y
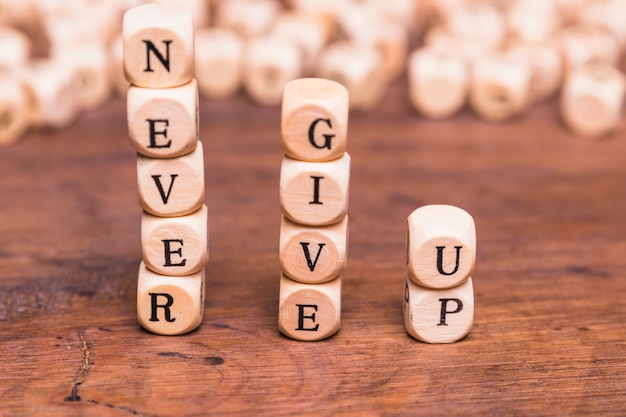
123,4 -> 208,335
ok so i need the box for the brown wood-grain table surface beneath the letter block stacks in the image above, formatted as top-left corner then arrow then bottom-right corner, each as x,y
0,82 -> 626,417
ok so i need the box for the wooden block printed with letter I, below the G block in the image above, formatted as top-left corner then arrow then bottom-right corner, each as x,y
280,152 -> 350,226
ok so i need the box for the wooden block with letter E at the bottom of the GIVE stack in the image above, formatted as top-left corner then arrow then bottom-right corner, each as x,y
278,274 -> 342,342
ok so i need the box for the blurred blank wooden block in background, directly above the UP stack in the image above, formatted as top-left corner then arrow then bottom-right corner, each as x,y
408,48 -> 469,118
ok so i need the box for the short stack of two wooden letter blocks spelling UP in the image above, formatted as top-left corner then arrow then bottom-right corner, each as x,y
403,205 -> 476,343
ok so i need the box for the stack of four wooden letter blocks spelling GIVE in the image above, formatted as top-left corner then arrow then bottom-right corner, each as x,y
278,78 -> 350,341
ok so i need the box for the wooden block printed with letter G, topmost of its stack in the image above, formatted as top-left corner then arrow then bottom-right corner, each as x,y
281,78 -> 349,162
